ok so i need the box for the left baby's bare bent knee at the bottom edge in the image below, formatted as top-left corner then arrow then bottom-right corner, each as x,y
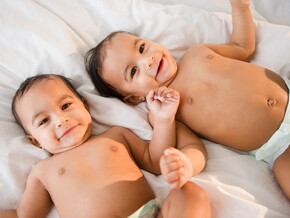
158,182 -> 211,218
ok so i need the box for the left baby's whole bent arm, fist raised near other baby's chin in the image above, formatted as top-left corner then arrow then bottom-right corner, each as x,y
119,86 -> 179,174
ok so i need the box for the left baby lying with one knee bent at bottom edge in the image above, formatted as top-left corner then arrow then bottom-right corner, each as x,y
0,74 -> 210,218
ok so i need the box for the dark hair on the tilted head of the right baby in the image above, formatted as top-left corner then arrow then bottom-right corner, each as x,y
85,30 -> 133,100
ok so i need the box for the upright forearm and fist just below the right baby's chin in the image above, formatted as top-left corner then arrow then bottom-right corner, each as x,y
146,86 -> 180,171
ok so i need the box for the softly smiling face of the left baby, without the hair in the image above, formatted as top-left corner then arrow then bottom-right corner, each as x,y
16,78 -> 92,154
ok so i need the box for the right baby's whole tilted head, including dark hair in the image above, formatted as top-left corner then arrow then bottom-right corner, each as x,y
85,31 -> 177,104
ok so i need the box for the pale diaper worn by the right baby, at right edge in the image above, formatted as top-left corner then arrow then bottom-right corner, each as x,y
250,77 -> 290,167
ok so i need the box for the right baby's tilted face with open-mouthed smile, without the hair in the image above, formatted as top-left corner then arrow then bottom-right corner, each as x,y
102,33 -> 177,101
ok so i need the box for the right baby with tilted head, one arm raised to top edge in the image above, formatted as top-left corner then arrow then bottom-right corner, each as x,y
86,0 -> 290,199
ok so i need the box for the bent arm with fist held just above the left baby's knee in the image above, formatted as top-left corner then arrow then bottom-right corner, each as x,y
160,122 -> 206,189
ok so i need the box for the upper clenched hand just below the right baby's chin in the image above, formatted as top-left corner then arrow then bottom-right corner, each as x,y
146,86 -> 180,120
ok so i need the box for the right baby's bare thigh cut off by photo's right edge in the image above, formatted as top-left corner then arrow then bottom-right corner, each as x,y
273,147 -> 290,200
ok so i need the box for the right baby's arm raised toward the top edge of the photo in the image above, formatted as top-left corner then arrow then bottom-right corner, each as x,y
207,0 -> 256,61
